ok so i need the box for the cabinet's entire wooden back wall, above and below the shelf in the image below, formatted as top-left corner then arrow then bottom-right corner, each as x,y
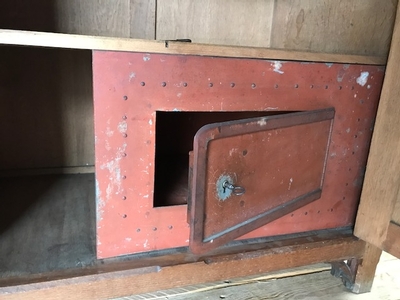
0,0 -> 397,170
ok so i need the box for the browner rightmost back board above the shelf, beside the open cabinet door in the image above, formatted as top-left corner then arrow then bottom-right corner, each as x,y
271,0 -> 397,56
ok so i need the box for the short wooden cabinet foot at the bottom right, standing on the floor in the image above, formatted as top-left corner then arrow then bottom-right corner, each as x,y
331,243 -> 382,294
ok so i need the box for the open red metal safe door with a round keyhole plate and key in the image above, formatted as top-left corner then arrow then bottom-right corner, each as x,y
188,108 -> 335,254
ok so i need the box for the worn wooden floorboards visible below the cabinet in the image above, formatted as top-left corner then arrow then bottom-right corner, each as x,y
115,253 -> 400,300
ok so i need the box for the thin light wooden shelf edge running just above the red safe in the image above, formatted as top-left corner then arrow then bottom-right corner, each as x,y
0,29 -> 387,65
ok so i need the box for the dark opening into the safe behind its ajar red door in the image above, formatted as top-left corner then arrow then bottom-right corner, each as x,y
154,111 -> 282,207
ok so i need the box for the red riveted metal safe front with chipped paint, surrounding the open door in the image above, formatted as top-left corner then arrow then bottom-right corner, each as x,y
93,51 -> 384,258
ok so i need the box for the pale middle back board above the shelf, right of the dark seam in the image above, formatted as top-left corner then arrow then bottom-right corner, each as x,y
156,0 -> 274,47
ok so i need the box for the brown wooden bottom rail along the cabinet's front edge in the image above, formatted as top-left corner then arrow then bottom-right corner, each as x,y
0,237 -> 365,300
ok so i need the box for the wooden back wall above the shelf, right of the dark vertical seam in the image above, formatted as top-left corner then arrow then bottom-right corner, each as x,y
156,0 -> 397,56
